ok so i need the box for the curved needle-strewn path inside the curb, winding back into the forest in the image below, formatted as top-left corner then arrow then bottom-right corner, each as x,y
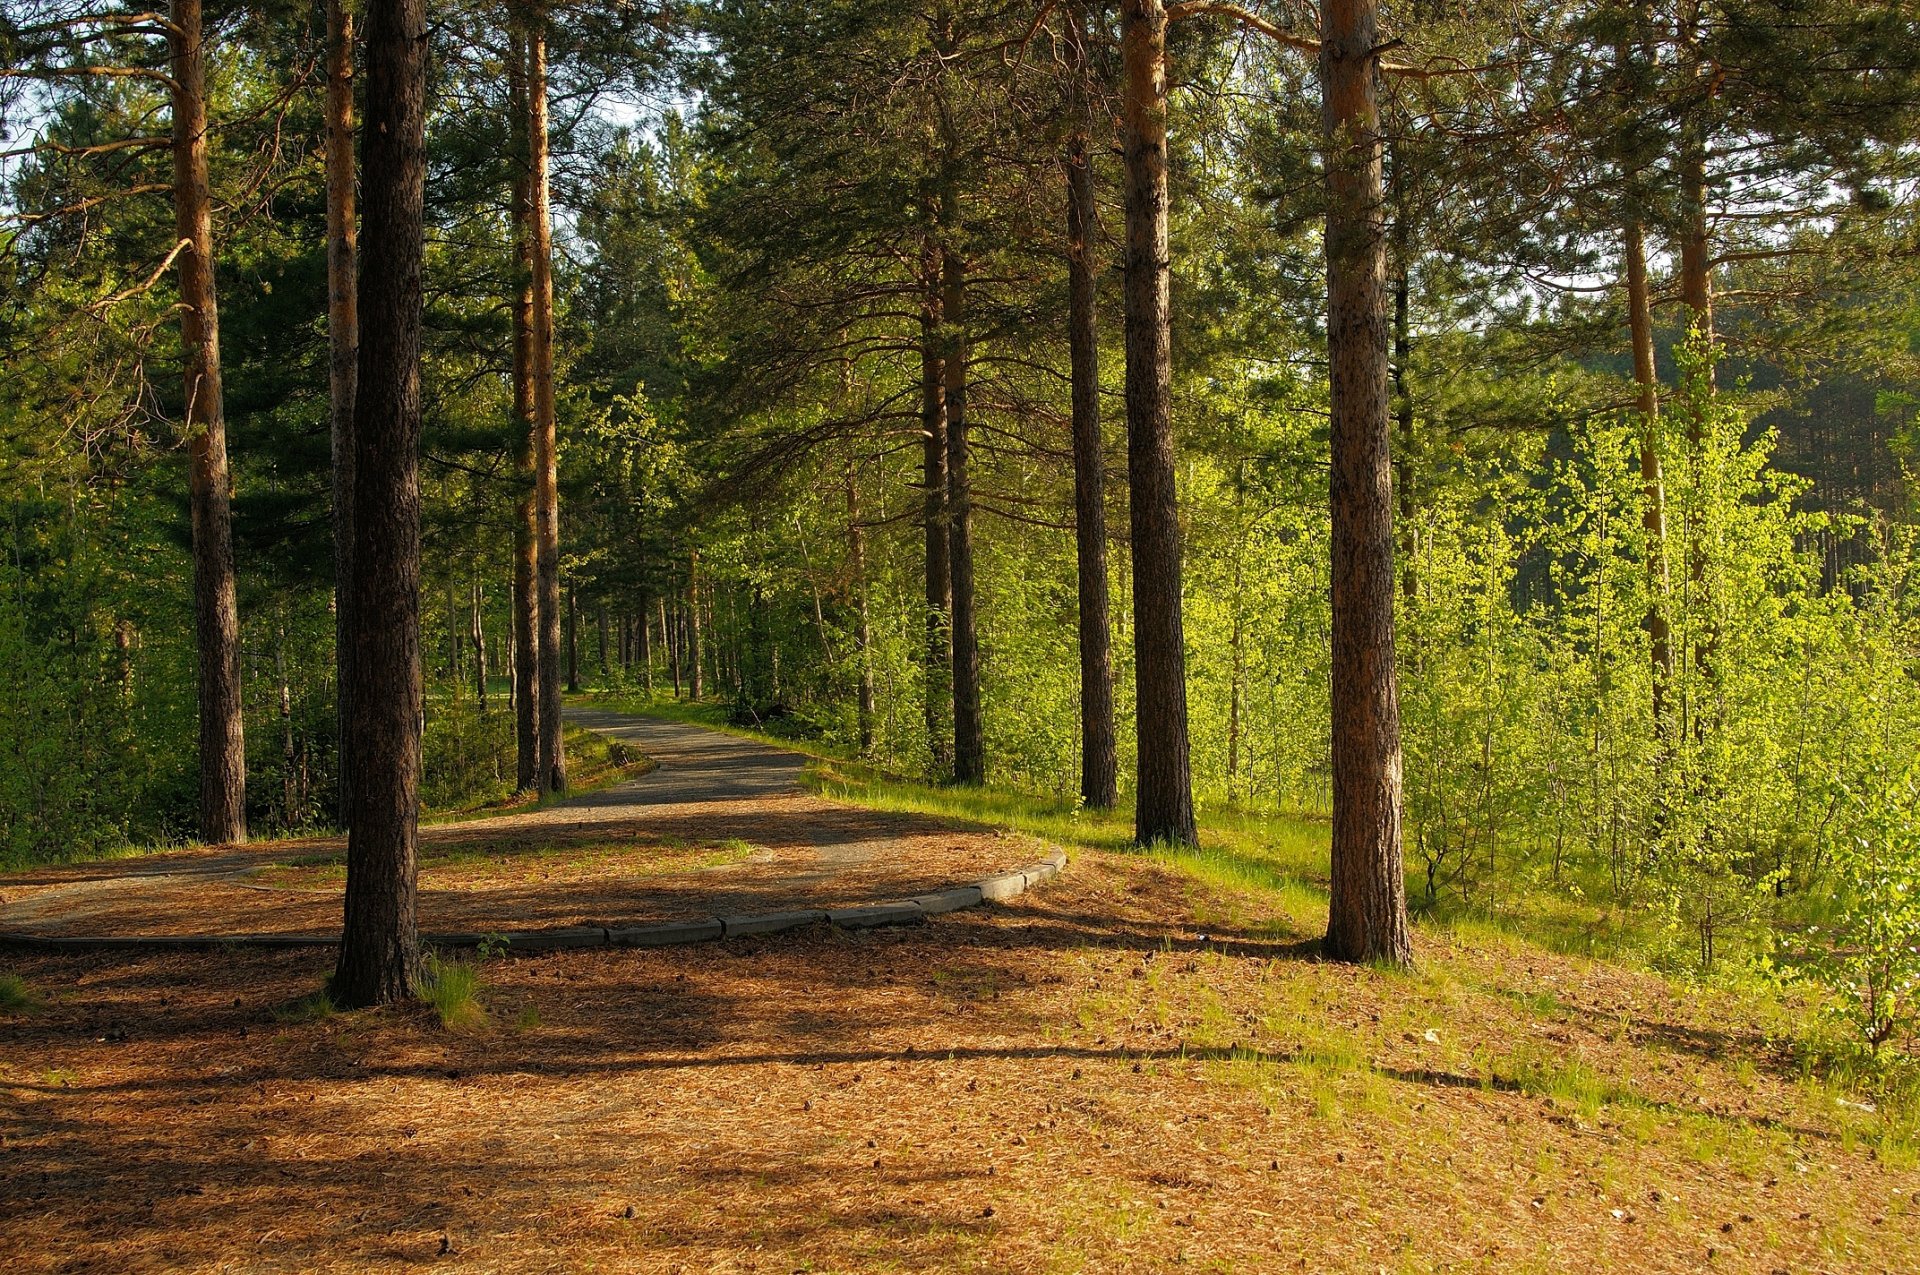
0,709 -> 1066,947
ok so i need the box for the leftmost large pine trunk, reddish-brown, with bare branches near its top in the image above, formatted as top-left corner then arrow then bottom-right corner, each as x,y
169,0 -> 246,843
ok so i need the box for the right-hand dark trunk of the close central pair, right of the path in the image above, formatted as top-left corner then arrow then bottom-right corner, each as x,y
941,252 -> 987,783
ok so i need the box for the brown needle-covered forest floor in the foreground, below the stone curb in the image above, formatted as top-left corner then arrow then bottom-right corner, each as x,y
0,853 -> 1920,1275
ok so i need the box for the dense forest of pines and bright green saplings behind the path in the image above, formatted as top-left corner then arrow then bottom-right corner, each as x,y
0,0 -> 1920,1021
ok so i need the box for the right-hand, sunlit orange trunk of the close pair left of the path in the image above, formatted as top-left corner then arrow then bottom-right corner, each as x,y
526,4 -> 566,793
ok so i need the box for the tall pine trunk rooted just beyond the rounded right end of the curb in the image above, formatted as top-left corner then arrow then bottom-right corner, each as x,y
1121,0 -> 1198,845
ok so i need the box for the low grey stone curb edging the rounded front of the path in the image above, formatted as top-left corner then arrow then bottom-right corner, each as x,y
0,851 -> 1068,952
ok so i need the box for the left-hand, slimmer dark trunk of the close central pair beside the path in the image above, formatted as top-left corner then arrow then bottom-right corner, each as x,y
920,238 -> 952,780
